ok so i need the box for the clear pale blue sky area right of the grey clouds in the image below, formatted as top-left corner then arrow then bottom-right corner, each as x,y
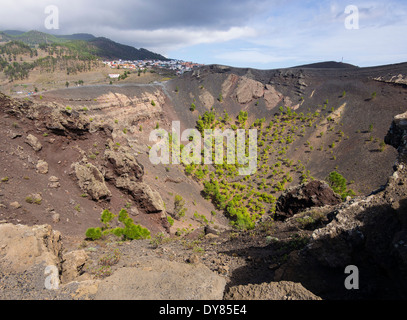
170,1 -> 407,69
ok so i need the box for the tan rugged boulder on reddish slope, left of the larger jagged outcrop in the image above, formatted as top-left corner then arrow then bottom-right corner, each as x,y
72,160 -> 111,200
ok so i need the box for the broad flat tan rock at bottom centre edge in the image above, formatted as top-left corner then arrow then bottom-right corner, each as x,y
95,258 -> 226,300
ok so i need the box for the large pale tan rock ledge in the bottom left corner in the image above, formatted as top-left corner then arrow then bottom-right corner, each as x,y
0,224 -> 98,300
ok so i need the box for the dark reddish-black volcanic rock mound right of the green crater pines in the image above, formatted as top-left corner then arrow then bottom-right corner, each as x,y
275,180 -> 341,220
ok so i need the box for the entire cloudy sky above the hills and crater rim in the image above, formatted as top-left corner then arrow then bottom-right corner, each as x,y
0,0 -> 407,69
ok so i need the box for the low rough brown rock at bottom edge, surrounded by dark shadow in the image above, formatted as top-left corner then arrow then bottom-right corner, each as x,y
224,281 -> 321,300
